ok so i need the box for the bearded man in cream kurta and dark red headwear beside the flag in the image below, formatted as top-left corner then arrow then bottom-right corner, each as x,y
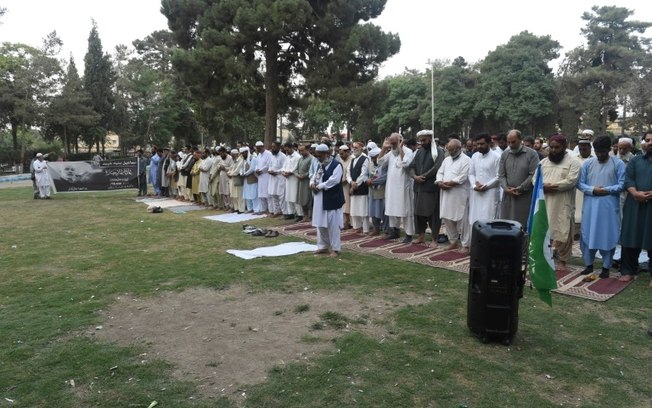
533,134 -> 580,268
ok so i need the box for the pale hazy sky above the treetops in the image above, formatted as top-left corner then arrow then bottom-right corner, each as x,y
0,0 -> 652,77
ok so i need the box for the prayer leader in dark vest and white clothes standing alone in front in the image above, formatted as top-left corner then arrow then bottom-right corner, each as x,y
310,144 -> 344,256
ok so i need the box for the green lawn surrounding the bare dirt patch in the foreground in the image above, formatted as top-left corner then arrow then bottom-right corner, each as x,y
0,188 -> 652,408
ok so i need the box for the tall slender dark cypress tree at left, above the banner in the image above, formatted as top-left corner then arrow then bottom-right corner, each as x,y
84,21 -> 116,152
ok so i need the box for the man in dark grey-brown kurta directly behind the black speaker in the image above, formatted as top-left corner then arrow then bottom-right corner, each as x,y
498,129 -> 539,227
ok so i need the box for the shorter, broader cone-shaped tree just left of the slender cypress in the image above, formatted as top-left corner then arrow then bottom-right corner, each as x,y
46,56 -> 100,156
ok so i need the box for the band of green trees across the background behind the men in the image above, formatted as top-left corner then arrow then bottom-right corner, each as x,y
0,4 -> 652,161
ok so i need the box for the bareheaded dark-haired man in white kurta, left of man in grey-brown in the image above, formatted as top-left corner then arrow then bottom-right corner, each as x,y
469,133 -> 500,225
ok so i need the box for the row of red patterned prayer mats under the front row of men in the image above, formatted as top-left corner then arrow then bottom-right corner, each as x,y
279,223 -> 632,302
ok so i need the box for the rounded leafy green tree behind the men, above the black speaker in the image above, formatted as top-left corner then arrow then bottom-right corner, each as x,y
476,31 -> 559,134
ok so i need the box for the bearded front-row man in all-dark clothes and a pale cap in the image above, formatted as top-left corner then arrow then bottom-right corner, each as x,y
410,130 -> 444,248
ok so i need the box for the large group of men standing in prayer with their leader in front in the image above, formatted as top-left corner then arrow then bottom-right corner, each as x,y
140,129 -> 652,280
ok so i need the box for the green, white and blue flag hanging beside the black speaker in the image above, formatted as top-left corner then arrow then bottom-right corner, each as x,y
527,164 -> 557,306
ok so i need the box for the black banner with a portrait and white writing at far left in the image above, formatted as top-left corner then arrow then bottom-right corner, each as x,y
48,158 -> 138,192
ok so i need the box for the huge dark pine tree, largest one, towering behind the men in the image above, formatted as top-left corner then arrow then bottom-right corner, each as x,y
161,0 -> 400,143
